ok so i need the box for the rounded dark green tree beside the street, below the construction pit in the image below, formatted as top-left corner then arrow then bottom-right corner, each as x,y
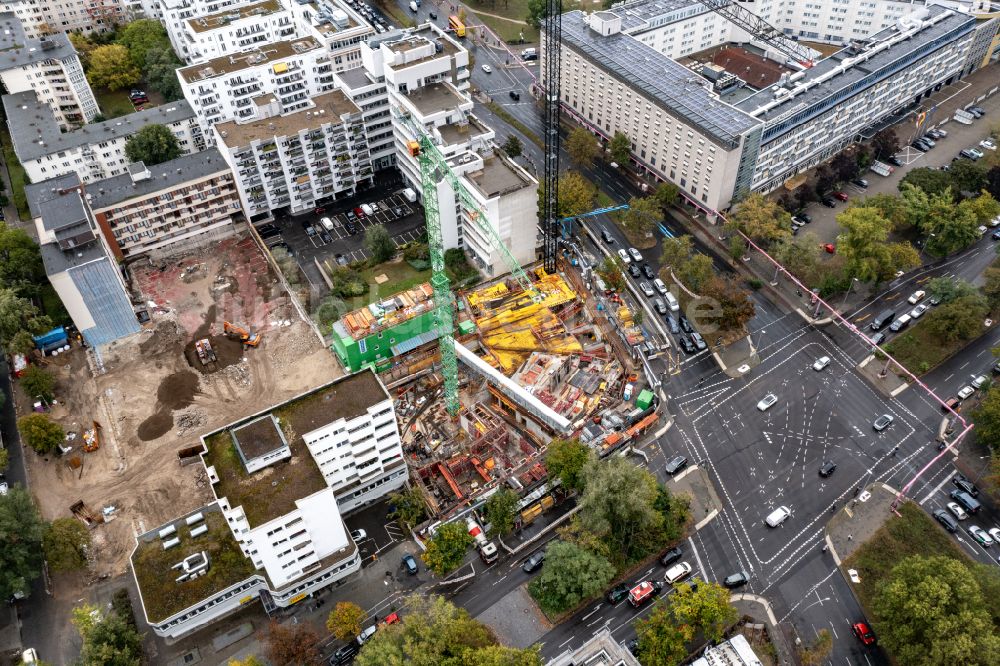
528,541 -> 615,614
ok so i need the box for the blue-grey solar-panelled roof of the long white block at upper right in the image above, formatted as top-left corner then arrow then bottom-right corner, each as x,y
562,10 -> 760,149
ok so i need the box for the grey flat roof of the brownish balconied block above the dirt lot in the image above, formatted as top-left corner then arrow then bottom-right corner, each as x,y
86,148 -> 231,211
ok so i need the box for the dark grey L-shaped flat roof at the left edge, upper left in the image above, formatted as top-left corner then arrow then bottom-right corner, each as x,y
3,90 -> 195,162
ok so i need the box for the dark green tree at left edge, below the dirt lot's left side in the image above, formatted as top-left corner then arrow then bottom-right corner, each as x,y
0,486 -> 45,599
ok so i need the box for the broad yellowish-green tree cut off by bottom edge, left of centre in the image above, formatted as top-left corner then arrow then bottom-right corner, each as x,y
354,594 -> 541,666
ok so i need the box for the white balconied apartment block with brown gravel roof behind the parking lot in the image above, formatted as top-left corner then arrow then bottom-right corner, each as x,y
213,85 -> 373,219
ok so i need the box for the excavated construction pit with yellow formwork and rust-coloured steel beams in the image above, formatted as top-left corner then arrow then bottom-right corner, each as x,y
368,268 -> 658,520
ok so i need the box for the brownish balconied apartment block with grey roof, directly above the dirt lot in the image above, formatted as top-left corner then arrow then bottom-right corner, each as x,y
86,148 -> 243,260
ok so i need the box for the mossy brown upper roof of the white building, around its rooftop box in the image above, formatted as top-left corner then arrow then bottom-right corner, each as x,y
202,370 -> 389,527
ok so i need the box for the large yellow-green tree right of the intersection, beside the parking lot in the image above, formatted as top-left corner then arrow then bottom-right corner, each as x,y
837,206 -> 920,282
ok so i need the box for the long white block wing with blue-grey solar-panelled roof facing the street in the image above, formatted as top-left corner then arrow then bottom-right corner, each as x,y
542,11 -> 762,210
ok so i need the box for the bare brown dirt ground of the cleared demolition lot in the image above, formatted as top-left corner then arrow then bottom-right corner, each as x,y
19,233 -> 341,576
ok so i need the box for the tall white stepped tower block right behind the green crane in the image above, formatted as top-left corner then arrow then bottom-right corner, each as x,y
361,24 -> 538,274
